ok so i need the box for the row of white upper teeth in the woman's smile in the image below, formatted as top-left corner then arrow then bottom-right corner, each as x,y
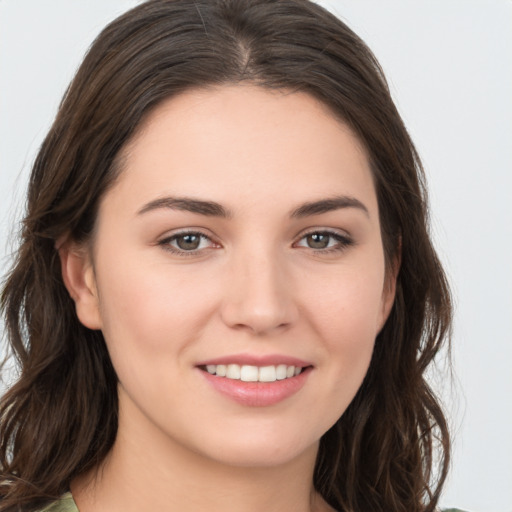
206,364 -> 302,382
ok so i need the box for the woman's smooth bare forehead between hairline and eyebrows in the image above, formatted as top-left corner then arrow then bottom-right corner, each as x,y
110,85 -> 374,216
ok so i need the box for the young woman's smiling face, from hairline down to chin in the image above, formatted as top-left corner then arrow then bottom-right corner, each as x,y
70,86 -> 394,466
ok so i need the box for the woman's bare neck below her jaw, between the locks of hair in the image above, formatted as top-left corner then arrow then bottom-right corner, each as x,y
71,390 -> 331,512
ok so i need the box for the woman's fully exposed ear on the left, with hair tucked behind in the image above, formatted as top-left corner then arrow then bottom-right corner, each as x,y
57,240 -> 102,329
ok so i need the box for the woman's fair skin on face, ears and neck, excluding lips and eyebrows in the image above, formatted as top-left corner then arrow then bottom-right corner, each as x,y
60,85 -> 394,512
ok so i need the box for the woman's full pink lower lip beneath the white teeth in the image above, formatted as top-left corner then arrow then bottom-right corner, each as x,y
199,367 -> 312,407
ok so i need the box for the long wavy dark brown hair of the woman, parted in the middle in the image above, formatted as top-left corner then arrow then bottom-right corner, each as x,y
0,0 -> 451,512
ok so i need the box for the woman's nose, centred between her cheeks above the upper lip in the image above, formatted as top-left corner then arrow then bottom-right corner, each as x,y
221,252 -> 298,336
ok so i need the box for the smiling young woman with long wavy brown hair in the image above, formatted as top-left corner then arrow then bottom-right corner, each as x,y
0,0 -> 451,512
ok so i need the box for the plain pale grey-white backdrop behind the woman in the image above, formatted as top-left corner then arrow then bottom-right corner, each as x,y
0,0 -> 512,512
